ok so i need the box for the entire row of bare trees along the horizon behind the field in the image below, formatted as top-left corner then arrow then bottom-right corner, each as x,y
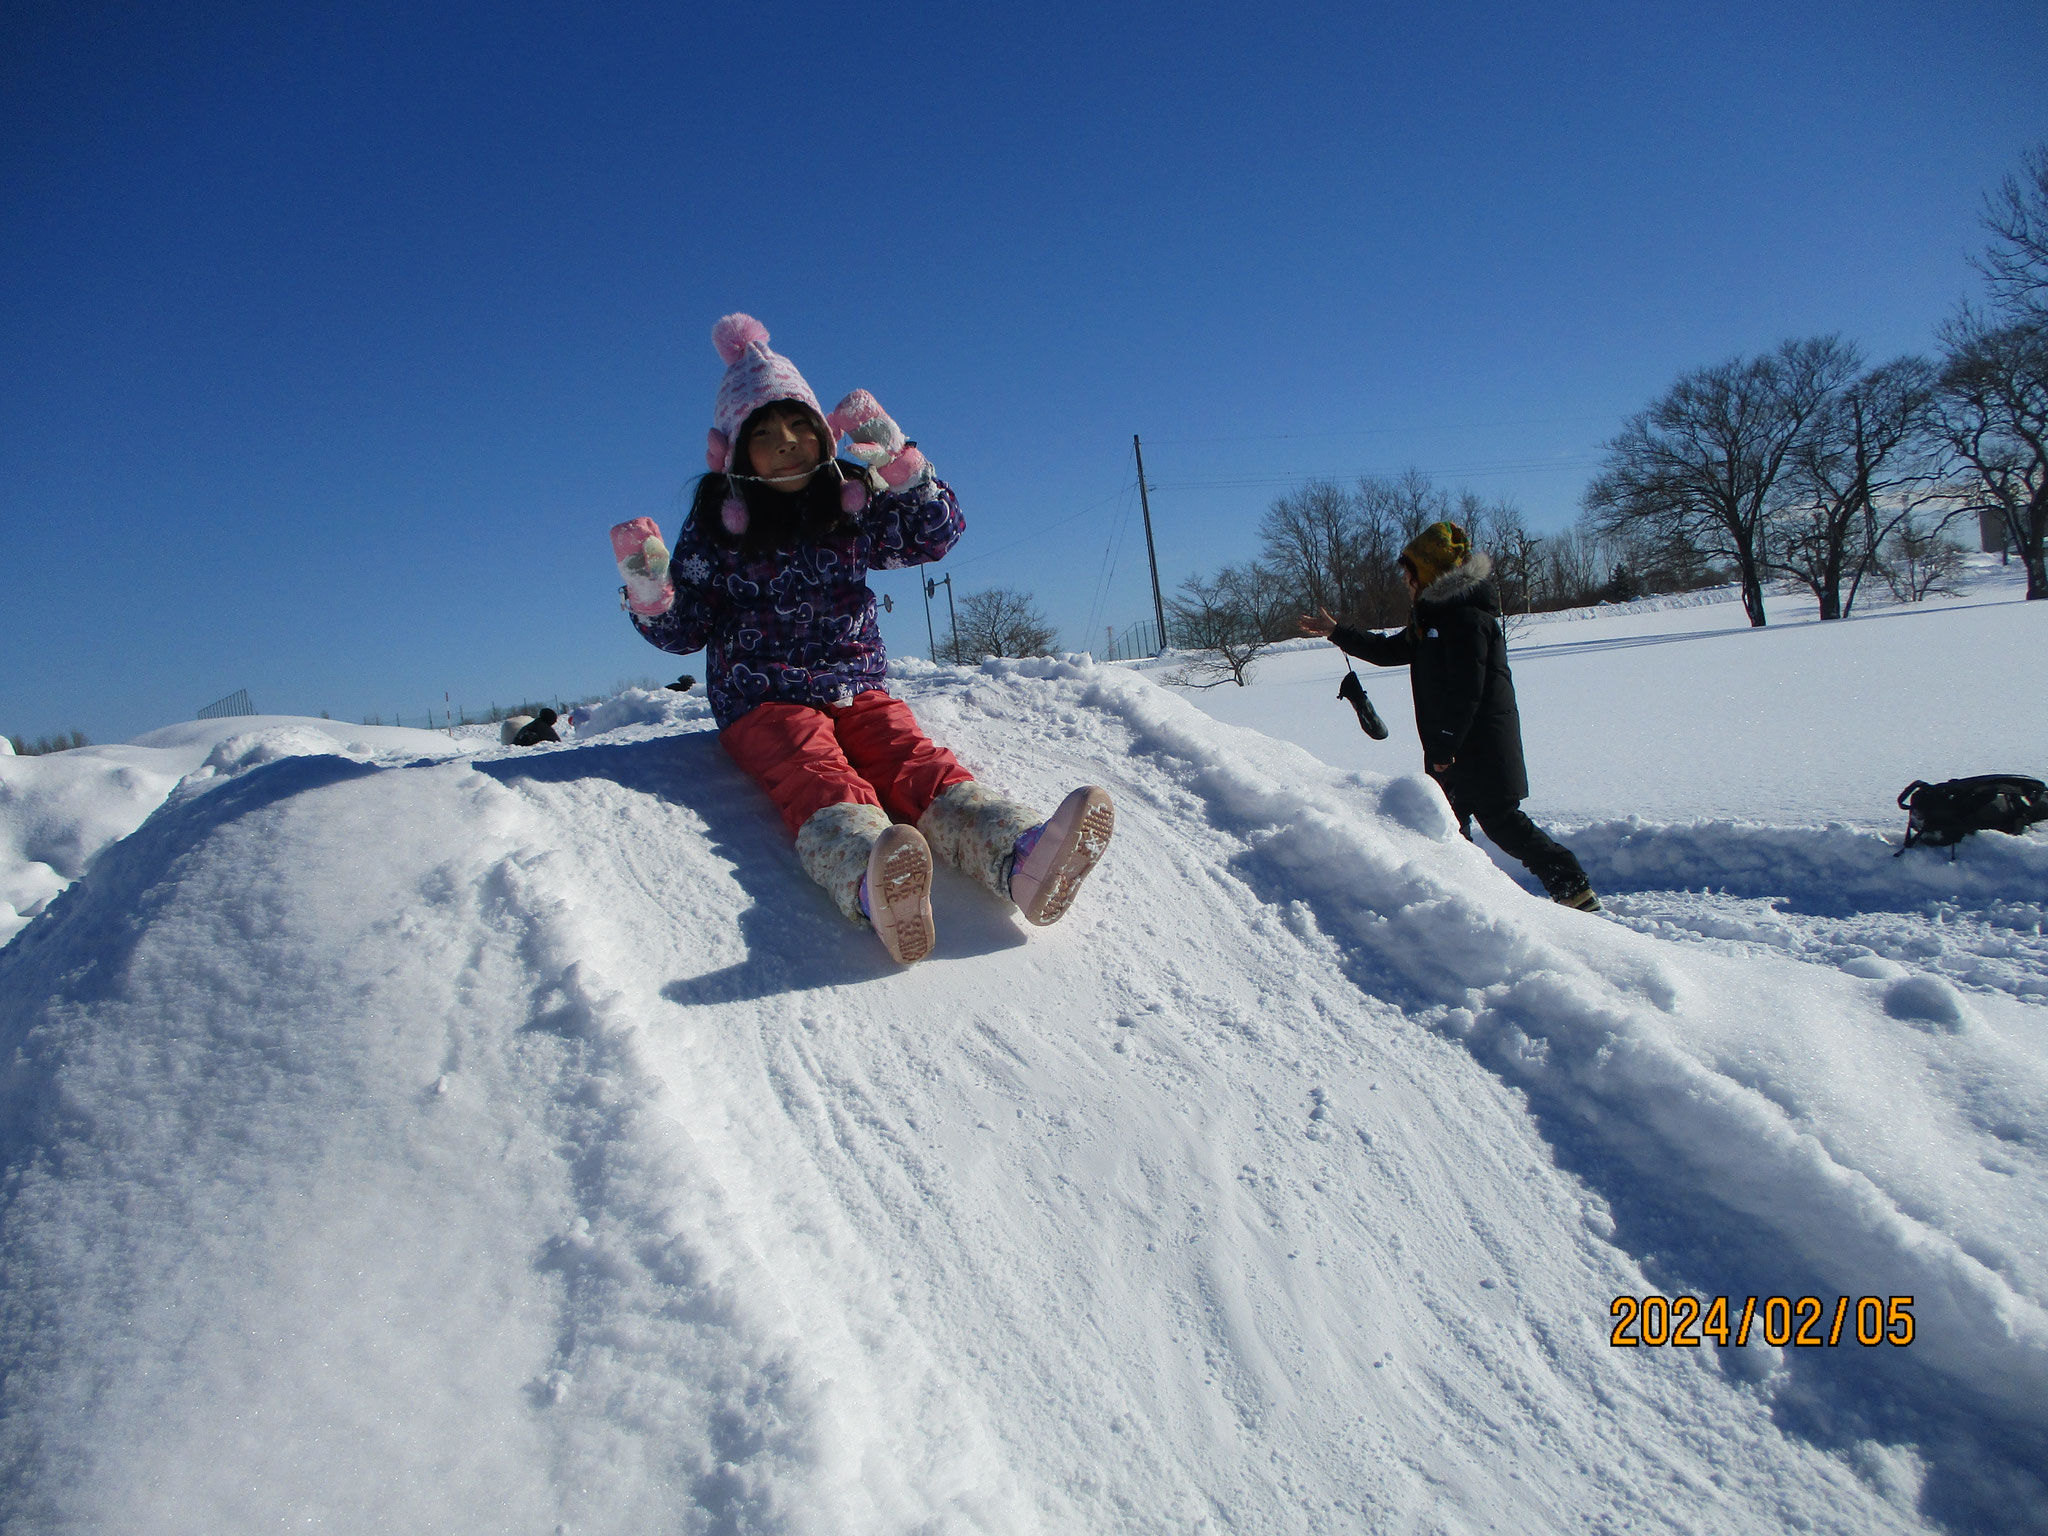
1169,145 -> 2048,686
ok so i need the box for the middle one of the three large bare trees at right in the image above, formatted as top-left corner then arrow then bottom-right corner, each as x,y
1772,346 -> 1939,618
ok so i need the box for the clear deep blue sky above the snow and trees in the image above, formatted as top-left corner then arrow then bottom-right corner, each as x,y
0,0 -> 2048,739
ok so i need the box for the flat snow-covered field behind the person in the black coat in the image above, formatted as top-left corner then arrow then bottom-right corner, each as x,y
1171,559 -> 2048,1015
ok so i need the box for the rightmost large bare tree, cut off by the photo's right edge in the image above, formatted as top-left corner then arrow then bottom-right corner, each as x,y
1935,309 -> 2048,600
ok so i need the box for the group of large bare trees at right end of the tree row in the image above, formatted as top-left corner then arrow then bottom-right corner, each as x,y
1585,145 -> 2048,625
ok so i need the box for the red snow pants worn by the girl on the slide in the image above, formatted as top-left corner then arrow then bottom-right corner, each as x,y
719,688 -> 973,836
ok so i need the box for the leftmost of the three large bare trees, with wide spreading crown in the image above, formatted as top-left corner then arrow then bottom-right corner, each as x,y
1585,336 -> 1858,627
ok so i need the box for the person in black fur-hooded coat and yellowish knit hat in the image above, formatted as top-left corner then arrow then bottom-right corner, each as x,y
1300,522 -> 1599,911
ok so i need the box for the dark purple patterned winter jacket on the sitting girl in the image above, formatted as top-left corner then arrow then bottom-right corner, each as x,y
633,468 -> 967,731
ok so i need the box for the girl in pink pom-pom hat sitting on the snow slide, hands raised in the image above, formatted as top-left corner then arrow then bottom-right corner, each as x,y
612,315 -> 1114,965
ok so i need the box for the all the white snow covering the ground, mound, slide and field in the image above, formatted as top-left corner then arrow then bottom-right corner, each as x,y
0,573 -> 2048,1536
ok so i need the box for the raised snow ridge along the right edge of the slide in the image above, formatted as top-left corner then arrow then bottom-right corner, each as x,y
1064,663 -> 2048,1430
